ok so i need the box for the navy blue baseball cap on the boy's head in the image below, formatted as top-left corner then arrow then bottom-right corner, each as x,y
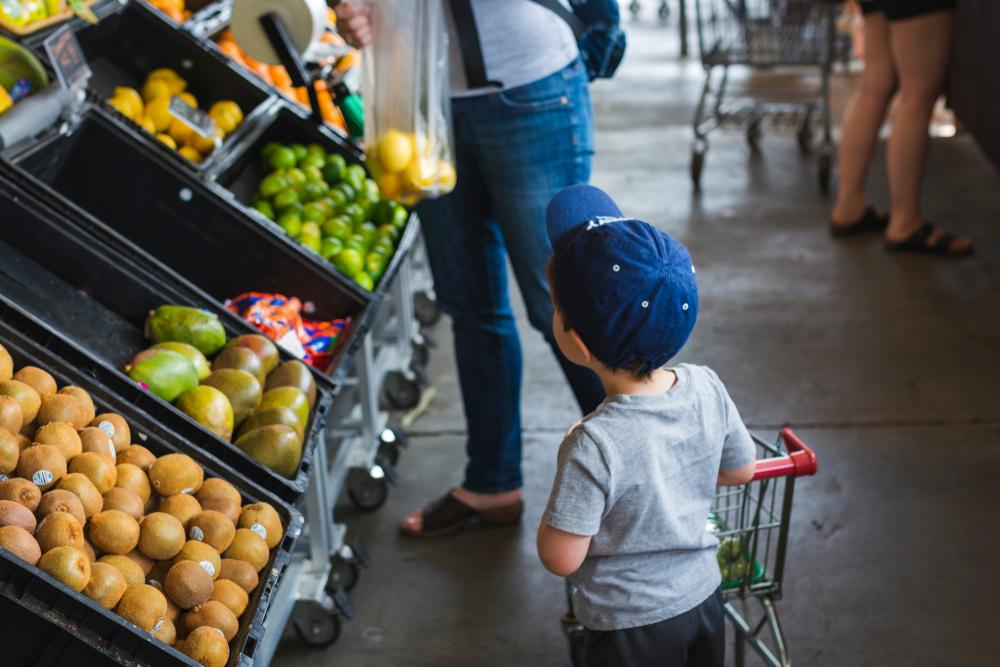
546,185 -> 698,372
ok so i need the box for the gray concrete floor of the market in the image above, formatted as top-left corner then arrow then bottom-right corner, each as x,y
275,11 -> 1000,667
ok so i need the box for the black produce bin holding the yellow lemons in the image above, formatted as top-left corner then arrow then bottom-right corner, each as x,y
47,2 -> 274,175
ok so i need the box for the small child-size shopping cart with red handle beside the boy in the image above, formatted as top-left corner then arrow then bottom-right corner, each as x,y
562,428 -> 817,667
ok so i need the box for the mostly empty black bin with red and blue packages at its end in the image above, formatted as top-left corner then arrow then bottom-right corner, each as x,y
6,106 -> 377,380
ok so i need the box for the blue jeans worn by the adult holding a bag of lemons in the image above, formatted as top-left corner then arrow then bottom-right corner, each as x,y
418,62 -> 604,493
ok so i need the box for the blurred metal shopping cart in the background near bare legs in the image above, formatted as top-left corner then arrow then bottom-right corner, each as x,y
691,0 -> 836,194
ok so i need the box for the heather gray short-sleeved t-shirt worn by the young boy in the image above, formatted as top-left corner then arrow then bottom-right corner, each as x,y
542,364 -> 755,630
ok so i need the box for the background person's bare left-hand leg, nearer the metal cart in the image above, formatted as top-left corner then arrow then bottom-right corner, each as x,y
831,12 -> 896,226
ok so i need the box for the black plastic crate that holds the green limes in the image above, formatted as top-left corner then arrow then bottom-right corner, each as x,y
212,101 -> 420,296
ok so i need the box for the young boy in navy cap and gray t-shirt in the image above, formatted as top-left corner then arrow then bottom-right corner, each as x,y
538,185 -> 755,667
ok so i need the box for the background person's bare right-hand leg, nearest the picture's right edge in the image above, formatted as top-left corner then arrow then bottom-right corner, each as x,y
886,11 -> 972,251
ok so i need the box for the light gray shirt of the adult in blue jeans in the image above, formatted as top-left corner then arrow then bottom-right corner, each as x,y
444,0 -> 579,97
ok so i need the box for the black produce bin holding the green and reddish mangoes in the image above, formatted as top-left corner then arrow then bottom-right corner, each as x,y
0,178 -> 336,500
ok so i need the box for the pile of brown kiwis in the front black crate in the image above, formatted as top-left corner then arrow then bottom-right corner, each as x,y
0,345 -> 284,667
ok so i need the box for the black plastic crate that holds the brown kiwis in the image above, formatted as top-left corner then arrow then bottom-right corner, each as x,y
0,298 -> 303,667
